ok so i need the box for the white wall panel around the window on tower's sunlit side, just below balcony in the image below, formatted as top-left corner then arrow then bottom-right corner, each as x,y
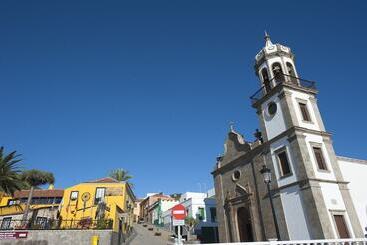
288,90 -> 320,131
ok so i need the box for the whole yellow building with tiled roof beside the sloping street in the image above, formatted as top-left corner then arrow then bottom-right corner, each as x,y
59,177 -> 135,233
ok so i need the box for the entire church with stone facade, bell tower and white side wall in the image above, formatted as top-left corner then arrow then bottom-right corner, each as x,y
212,34 -> 367,242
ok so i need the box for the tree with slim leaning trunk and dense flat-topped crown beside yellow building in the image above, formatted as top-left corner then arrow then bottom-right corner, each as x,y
21,169 -> 55,225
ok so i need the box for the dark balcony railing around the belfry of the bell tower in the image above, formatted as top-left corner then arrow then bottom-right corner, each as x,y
250,74 -> 316,104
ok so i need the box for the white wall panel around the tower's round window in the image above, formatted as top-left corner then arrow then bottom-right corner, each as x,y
261,94 -> 286,140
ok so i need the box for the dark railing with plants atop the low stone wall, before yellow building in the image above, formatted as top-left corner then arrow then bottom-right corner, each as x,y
0,218 -> 113,231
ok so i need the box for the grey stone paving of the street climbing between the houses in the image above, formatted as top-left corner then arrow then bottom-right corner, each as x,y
129,224 -> 172,245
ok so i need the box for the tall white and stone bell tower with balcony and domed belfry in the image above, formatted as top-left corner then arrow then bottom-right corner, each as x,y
251,33 -> 363,240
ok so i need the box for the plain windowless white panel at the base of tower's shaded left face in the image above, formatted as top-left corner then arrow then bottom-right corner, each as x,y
280,186 -> 311,240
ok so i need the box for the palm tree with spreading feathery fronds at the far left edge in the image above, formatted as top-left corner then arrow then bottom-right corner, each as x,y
0,147 -> 23,195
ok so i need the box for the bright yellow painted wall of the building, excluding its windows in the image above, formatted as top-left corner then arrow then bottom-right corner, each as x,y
60,182 -> 134,231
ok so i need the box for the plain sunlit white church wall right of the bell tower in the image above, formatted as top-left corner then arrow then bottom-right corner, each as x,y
338,157 -> 367,233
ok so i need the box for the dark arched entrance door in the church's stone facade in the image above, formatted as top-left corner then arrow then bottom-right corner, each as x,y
237,207 -> 254,242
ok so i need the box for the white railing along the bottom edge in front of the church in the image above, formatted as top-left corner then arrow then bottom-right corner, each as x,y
200,238 -> 367,245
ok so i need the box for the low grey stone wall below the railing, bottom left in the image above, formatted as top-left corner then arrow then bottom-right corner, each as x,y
0,230 -> 118,245
